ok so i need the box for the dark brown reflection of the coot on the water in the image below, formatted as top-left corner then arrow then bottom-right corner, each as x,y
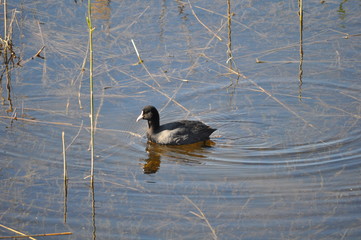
143,140 -> 215,174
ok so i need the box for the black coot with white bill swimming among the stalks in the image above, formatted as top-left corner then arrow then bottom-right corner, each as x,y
136,106 -> 216,145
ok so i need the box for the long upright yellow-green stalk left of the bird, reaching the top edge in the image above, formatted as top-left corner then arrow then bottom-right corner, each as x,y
87,0 -> 94,185
